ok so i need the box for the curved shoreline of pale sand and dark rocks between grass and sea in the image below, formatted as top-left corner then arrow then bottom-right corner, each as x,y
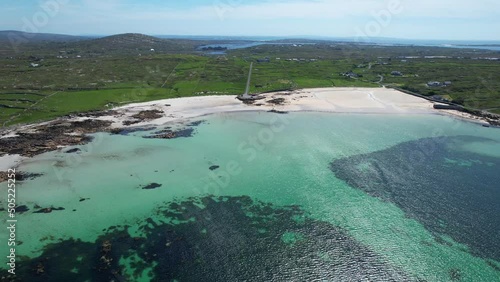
0,88 -> 490,173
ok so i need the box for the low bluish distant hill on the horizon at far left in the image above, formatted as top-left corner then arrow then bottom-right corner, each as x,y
0,30 -> 91,43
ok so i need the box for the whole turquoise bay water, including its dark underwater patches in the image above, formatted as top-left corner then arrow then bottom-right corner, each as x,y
0,112 -> 500,281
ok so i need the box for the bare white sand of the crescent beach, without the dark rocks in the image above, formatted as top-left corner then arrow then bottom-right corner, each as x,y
0,88 -> 486,171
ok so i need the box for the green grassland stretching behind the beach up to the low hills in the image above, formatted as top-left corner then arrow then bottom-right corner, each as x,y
0,36 -> 500,126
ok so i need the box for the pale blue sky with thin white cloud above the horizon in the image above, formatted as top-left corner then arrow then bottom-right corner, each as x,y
0,0 -> 500,40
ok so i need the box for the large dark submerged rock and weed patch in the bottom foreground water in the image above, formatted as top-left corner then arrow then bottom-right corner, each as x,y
0,196 -> 414,282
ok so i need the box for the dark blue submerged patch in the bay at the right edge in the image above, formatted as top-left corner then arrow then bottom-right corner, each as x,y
330,136 -> 500,261
